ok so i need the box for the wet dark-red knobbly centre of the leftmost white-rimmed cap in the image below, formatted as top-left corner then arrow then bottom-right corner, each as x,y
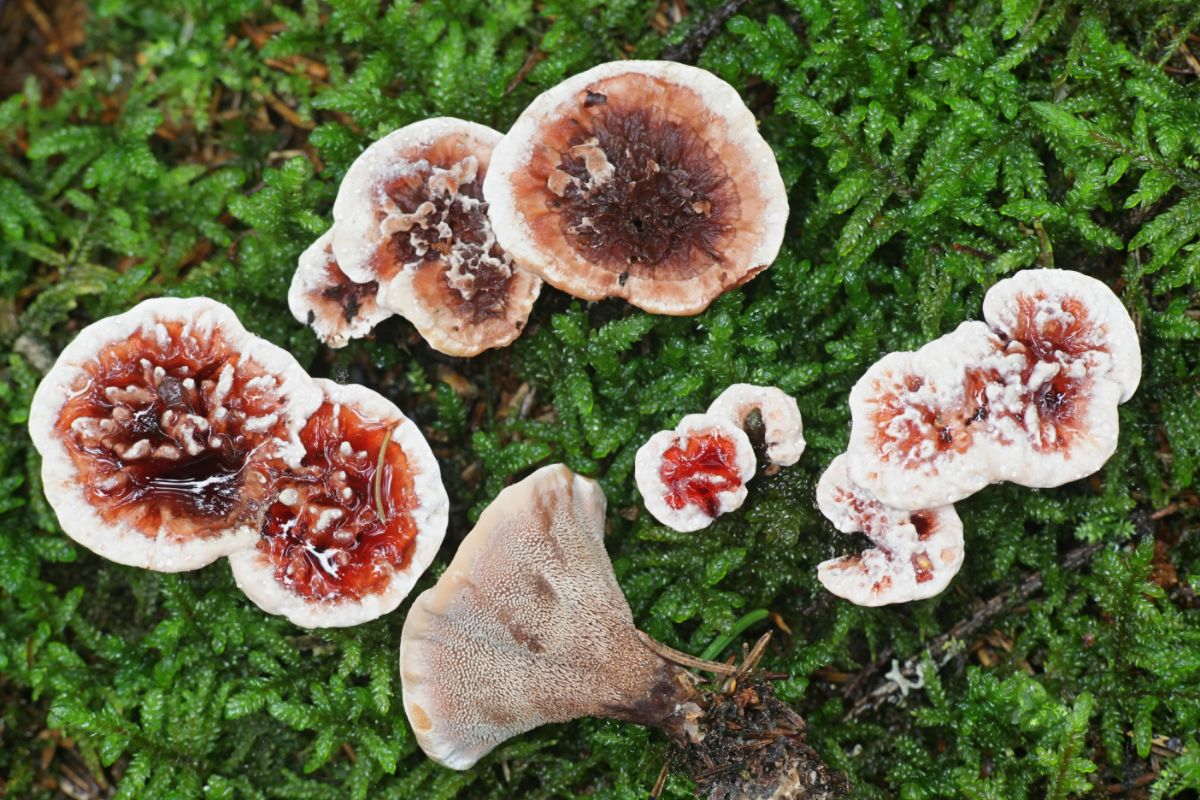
56,323 -> 296,537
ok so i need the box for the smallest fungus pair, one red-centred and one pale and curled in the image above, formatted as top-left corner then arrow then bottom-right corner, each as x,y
634,384 -> 805,531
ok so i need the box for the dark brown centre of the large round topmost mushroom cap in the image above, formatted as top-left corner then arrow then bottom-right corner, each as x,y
546,103 -> 738,279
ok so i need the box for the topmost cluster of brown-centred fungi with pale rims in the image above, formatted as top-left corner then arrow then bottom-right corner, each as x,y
289,61 -> 787,356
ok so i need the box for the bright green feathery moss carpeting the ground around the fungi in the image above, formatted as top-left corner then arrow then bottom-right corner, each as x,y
0,0 -> 1200,799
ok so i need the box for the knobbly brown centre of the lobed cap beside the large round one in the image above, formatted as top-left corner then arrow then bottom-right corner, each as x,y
373,137 -> 514,323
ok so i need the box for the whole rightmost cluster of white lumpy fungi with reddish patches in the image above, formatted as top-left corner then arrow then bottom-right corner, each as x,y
817,270 -> 1141,606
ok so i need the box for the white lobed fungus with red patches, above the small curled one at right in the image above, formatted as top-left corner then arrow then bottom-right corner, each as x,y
847,270 -> 1141,509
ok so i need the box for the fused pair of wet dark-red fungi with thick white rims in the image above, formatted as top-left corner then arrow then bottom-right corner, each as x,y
29,299 -> 449,627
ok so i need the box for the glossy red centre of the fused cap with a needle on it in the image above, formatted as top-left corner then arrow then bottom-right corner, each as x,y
258,402 -> 416,600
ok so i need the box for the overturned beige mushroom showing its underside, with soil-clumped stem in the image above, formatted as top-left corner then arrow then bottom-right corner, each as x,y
400,464 -> 845,800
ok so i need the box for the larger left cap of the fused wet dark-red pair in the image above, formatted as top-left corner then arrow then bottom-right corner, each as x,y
29,297 -> 320,572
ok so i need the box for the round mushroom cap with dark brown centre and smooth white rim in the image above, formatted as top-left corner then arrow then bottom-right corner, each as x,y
484,61 -> 787,315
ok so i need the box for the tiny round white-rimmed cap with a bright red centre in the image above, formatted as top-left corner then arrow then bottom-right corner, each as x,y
634,414 -> 756,531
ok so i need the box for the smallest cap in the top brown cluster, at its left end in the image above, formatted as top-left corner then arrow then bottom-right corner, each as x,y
288,229 -> 391,348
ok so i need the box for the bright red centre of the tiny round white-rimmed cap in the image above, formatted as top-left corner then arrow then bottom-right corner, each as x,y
659,433 -> 742,517
